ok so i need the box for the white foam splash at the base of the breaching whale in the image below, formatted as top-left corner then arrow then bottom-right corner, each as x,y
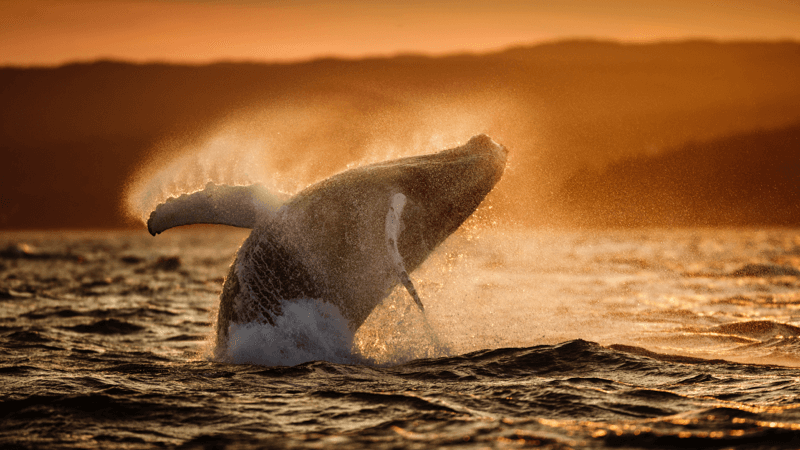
226,299 -> 358,366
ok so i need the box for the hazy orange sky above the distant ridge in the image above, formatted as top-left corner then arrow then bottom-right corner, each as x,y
0,0 -> 800,65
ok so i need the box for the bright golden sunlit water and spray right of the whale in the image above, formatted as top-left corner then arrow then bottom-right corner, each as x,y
356,229 -> 800,366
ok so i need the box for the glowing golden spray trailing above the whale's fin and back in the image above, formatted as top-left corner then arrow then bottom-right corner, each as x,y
125,93 -> 515,222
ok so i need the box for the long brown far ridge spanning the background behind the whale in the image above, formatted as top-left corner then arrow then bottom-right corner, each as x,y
0,41 -> 800,228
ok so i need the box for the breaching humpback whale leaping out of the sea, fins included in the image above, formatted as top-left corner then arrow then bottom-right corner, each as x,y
147,134 -> 508,352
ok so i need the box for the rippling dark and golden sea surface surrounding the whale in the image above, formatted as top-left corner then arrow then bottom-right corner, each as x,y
0,227 -> 800,449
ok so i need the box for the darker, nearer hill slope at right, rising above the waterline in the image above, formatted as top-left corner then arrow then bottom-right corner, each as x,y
554,124 -> 800,227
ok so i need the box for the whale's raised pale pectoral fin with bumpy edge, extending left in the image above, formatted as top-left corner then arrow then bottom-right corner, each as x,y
147,183 -> 282,236
